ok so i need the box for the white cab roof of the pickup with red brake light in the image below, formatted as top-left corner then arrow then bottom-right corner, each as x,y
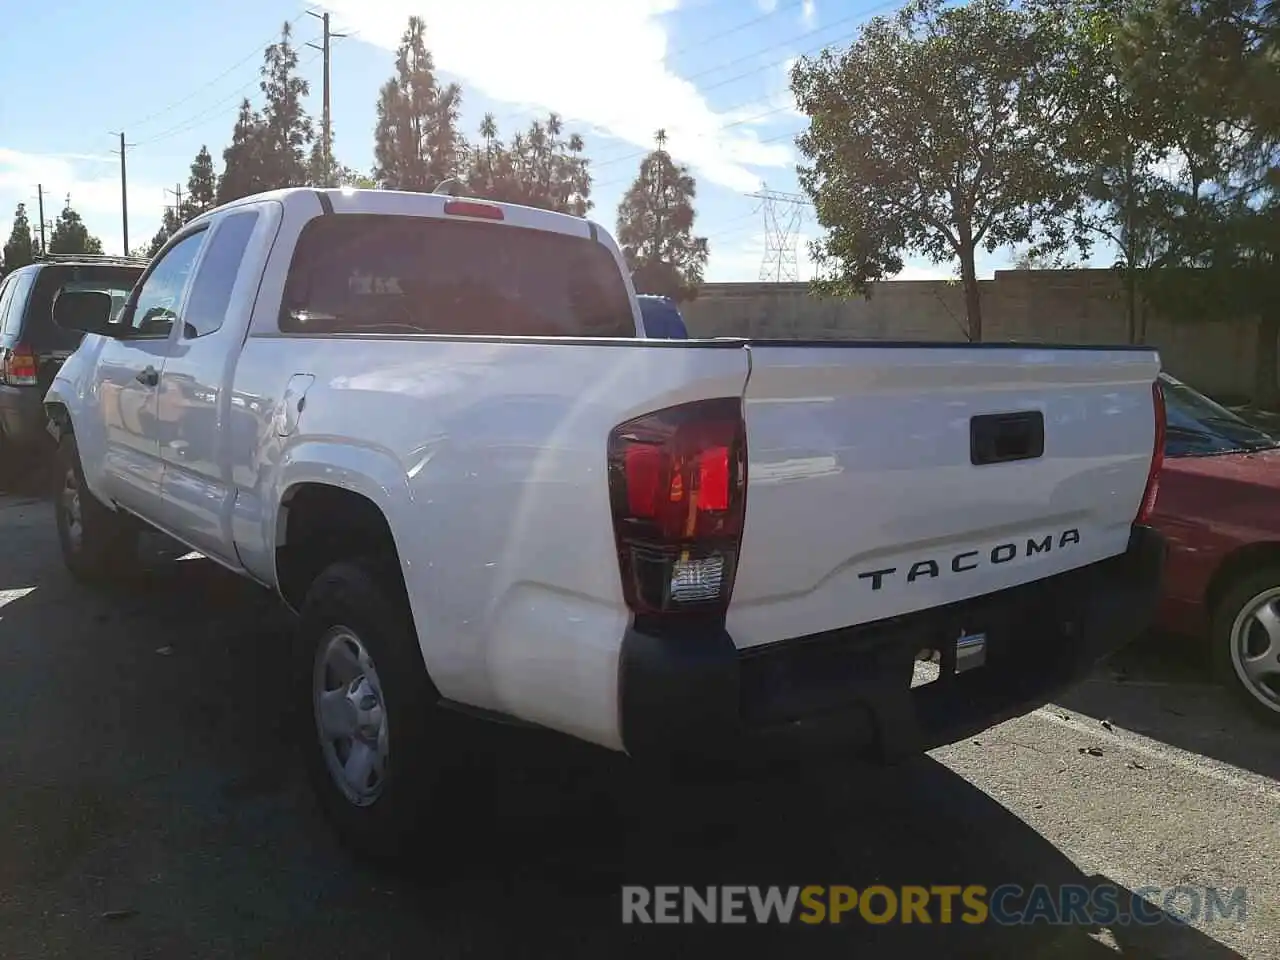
196,187 -> 600,237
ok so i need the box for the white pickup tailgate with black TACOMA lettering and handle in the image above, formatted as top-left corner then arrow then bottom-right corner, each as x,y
727,343 -> 1160,648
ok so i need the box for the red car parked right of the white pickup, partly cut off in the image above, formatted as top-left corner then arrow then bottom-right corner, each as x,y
1152,374 -> 1280,723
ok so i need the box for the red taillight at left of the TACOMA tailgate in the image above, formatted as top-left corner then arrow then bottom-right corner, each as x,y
609,397 -> 746,614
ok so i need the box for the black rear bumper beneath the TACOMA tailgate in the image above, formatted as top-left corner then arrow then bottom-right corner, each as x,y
621,526 -> 1165,760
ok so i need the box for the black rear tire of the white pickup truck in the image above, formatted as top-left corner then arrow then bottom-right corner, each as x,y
293,558 -> 452,865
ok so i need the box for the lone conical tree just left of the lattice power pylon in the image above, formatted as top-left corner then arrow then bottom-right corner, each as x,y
618,131 -> 710,301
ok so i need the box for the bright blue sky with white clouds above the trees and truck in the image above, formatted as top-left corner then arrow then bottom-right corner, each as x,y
0,0 -> 1012,282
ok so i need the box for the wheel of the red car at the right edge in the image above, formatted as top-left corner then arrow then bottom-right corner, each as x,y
1212,567 -> 1280,724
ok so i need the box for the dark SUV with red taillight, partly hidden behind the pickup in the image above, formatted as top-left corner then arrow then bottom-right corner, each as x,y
0,255 -> 147,474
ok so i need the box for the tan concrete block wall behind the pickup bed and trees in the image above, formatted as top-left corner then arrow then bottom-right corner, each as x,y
681,270 -> 1256,396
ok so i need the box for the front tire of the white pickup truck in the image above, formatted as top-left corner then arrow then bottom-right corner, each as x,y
54,434 -> 141,585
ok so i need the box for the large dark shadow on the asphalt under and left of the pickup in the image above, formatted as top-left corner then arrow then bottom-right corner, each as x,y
0,504 -> 1236,960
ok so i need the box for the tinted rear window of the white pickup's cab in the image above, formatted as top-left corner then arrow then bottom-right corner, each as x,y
280,214 -> 636,337
